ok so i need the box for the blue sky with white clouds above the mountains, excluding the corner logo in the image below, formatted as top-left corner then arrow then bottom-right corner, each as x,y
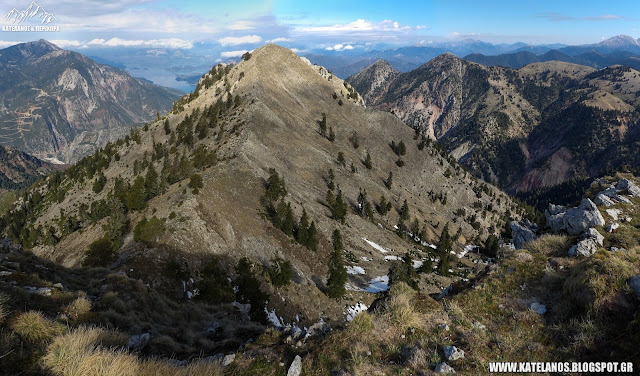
0,0 -> 640,53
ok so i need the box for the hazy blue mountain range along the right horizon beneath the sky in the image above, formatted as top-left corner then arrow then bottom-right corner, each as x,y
306,35 -> 640,78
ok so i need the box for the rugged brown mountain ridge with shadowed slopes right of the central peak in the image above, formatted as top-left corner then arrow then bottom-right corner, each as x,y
347,54 -> 640,192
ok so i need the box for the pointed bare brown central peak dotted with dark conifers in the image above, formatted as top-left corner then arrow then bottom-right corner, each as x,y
5,45 -> 522,332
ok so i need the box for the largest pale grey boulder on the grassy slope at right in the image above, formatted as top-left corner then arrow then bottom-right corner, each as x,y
545,198 -> 605,235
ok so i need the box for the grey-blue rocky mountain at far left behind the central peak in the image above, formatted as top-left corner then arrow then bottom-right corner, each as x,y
0,40 -> 180,162
